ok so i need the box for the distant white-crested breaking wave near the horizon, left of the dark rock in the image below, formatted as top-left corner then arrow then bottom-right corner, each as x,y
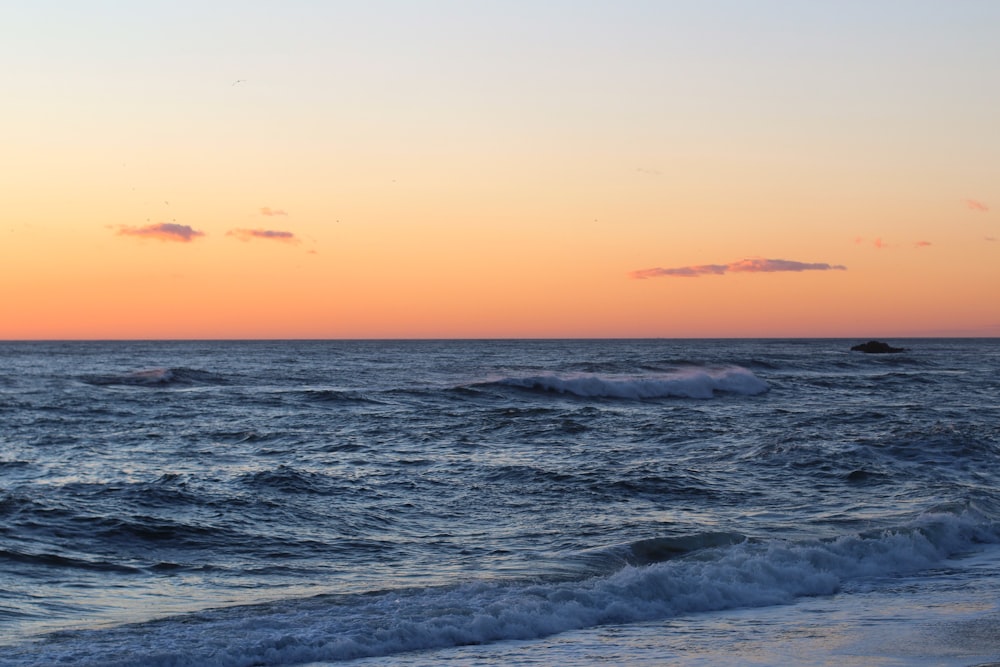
493,366 -> 768,400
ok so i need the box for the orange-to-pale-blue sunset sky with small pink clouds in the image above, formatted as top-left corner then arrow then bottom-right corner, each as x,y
0,0 -> 1000,340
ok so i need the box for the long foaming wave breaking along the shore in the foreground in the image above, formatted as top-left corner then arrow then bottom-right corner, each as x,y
5,508 -> 1000,667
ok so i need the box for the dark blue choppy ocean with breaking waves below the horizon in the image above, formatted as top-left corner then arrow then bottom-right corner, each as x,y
0,339 -> 1000,667
